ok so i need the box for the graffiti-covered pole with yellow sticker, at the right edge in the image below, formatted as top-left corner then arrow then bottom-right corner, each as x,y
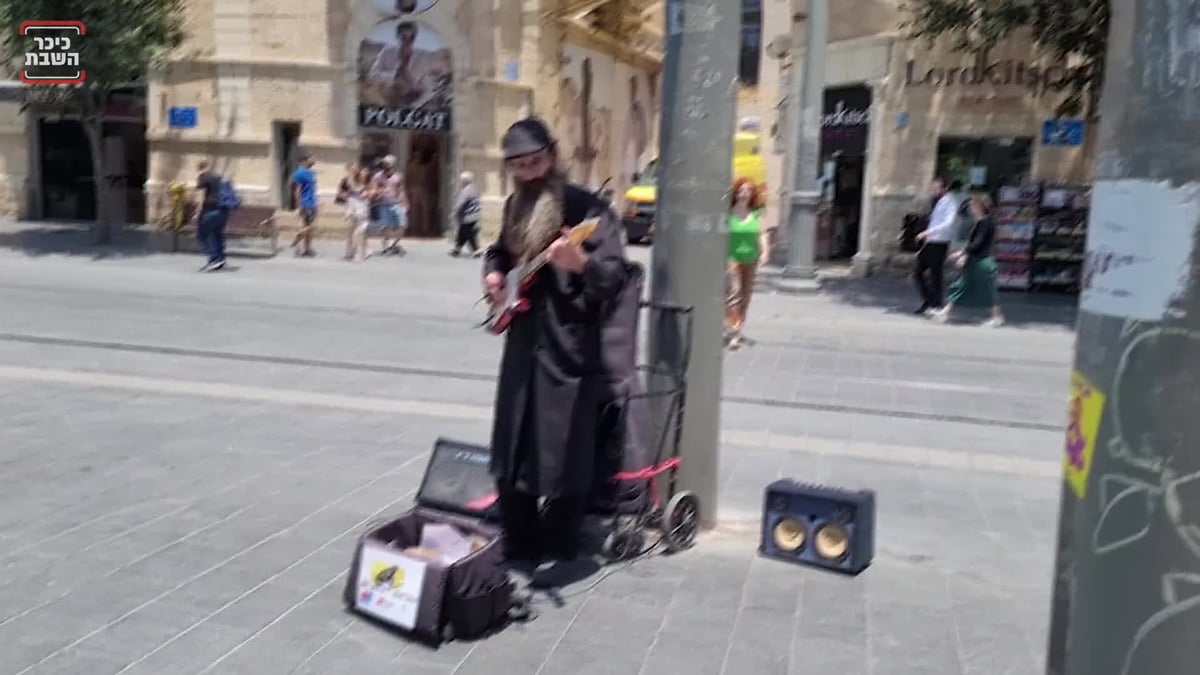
1046,0 -> 1200,675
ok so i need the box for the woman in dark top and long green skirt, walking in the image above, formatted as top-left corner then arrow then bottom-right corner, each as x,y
934,195 -> 1004,328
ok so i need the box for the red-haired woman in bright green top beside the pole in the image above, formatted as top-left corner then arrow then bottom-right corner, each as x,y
725,178 -> 769,350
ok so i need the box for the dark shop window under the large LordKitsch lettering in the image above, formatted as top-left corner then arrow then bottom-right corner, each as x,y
937,137 -> 1033,195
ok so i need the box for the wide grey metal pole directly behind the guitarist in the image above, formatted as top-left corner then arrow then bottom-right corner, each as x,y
650,0 -> 740,527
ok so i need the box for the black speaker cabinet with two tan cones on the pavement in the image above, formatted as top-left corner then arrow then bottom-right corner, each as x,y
758,479 -> 875,574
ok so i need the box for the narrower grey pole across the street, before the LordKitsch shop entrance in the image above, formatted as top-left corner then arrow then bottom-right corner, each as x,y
779,0 -> 829,292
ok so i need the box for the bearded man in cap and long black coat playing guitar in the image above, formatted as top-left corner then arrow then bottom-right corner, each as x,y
484,119 -> 626,576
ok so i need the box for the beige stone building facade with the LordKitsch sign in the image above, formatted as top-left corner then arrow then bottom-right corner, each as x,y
739,0 -> 1094,271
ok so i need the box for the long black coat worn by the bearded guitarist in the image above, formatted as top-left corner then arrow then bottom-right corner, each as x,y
484,185 -> 625,498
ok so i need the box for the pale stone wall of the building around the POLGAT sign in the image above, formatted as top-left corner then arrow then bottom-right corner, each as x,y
146,0 -> 660,234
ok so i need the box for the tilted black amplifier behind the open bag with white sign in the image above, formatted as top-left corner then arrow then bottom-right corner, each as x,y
420,438 -> 499,521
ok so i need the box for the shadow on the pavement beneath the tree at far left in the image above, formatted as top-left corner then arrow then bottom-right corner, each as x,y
0,222 -> 169,261
